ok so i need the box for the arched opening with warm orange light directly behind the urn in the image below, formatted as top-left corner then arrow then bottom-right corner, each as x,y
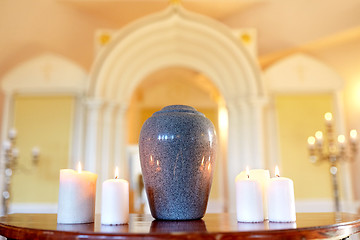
127,66 -> 227,212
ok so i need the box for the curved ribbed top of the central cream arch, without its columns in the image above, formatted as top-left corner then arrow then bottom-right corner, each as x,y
88,4 -> 264,103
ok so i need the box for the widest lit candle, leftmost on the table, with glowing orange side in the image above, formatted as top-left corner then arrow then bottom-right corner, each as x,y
57,163 -> 97,224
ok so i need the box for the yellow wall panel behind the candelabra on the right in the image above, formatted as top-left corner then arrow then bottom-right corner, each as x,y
275,95 -> 333,200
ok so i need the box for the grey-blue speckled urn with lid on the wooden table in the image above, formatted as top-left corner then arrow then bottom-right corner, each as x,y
139,105 -> 217,220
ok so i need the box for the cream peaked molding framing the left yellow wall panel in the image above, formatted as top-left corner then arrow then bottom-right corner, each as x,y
0,52 -> 88,212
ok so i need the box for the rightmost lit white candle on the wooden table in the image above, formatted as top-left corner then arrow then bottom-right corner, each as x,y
267,167 -> 296,222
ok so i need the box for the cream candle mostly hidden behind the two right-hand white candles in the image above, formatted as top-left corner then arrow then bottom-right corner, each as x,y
237,169 -> 270,219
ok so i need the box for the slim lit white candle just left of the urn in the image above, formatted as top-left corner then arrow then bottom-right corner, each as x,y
101,168 -> 129,225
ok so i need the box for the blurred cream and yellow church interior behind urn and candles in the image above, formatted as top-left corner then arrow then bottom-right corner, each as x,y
0,0 -> 360,225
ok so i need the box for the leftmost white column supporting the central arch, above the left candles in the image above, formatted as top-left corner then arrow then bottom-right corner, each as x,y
84,99 -> 103,173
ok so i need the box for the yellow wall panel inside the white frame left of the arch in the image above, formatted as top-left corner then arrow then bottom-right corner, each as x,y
11,96 -> 74,203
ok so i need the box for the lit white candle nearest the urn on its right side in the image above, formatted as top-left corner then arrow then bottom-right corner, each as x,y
235,168 -> 264,222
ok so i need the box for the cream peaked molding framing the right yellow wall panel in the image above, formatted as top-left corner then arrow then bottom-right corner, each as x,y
264,53 -> 355,212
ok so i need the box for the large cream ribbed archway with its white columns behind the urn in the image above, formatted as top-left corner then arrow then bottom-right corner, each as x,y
85,4 -> 264,211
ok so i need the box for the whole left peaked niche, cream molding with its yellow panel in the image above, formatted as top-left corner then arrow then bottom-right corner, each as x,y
0,53 -> 87,213
